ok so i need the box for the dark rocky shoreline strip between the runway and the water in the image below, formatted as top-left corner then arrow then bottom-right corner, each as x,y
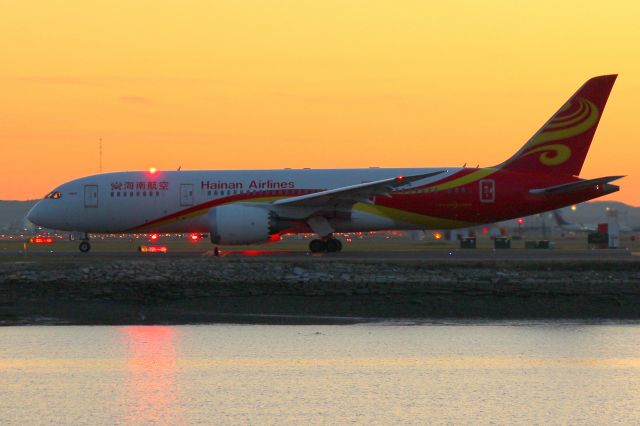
0,258 -> 640,325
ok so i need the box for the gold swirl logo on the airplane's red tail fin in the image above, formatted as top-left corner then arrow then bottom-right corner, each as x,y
520,98 -> 600,166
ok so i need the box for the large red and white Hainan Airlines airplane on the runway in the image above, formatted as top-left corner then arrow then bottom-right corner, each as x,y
27,75 -> 624,253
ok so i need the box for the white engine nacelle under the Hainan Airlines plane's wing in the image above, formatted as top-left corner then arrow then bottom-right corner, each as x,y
209,204 -> 277,245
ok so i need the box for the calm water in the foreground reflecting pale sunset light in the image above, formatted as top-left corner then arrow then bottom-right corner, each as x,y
0,322 -> 640,425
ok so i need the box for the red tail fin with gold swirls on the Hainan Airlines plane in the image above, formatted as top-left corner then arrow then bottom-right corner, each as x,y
499,75 -> 617,176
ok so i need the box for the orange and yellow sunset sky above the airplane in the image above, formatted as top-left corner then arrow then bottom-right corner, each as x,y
0,0 -> 640,205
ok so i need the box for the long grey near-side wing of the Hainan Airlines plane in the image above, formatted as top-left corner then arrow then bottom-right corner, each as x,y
272,170 -> 446,207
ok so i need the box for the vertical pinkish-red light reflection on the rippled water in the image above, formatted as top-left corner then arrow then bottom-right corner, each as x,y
122,326 -> 182,424
